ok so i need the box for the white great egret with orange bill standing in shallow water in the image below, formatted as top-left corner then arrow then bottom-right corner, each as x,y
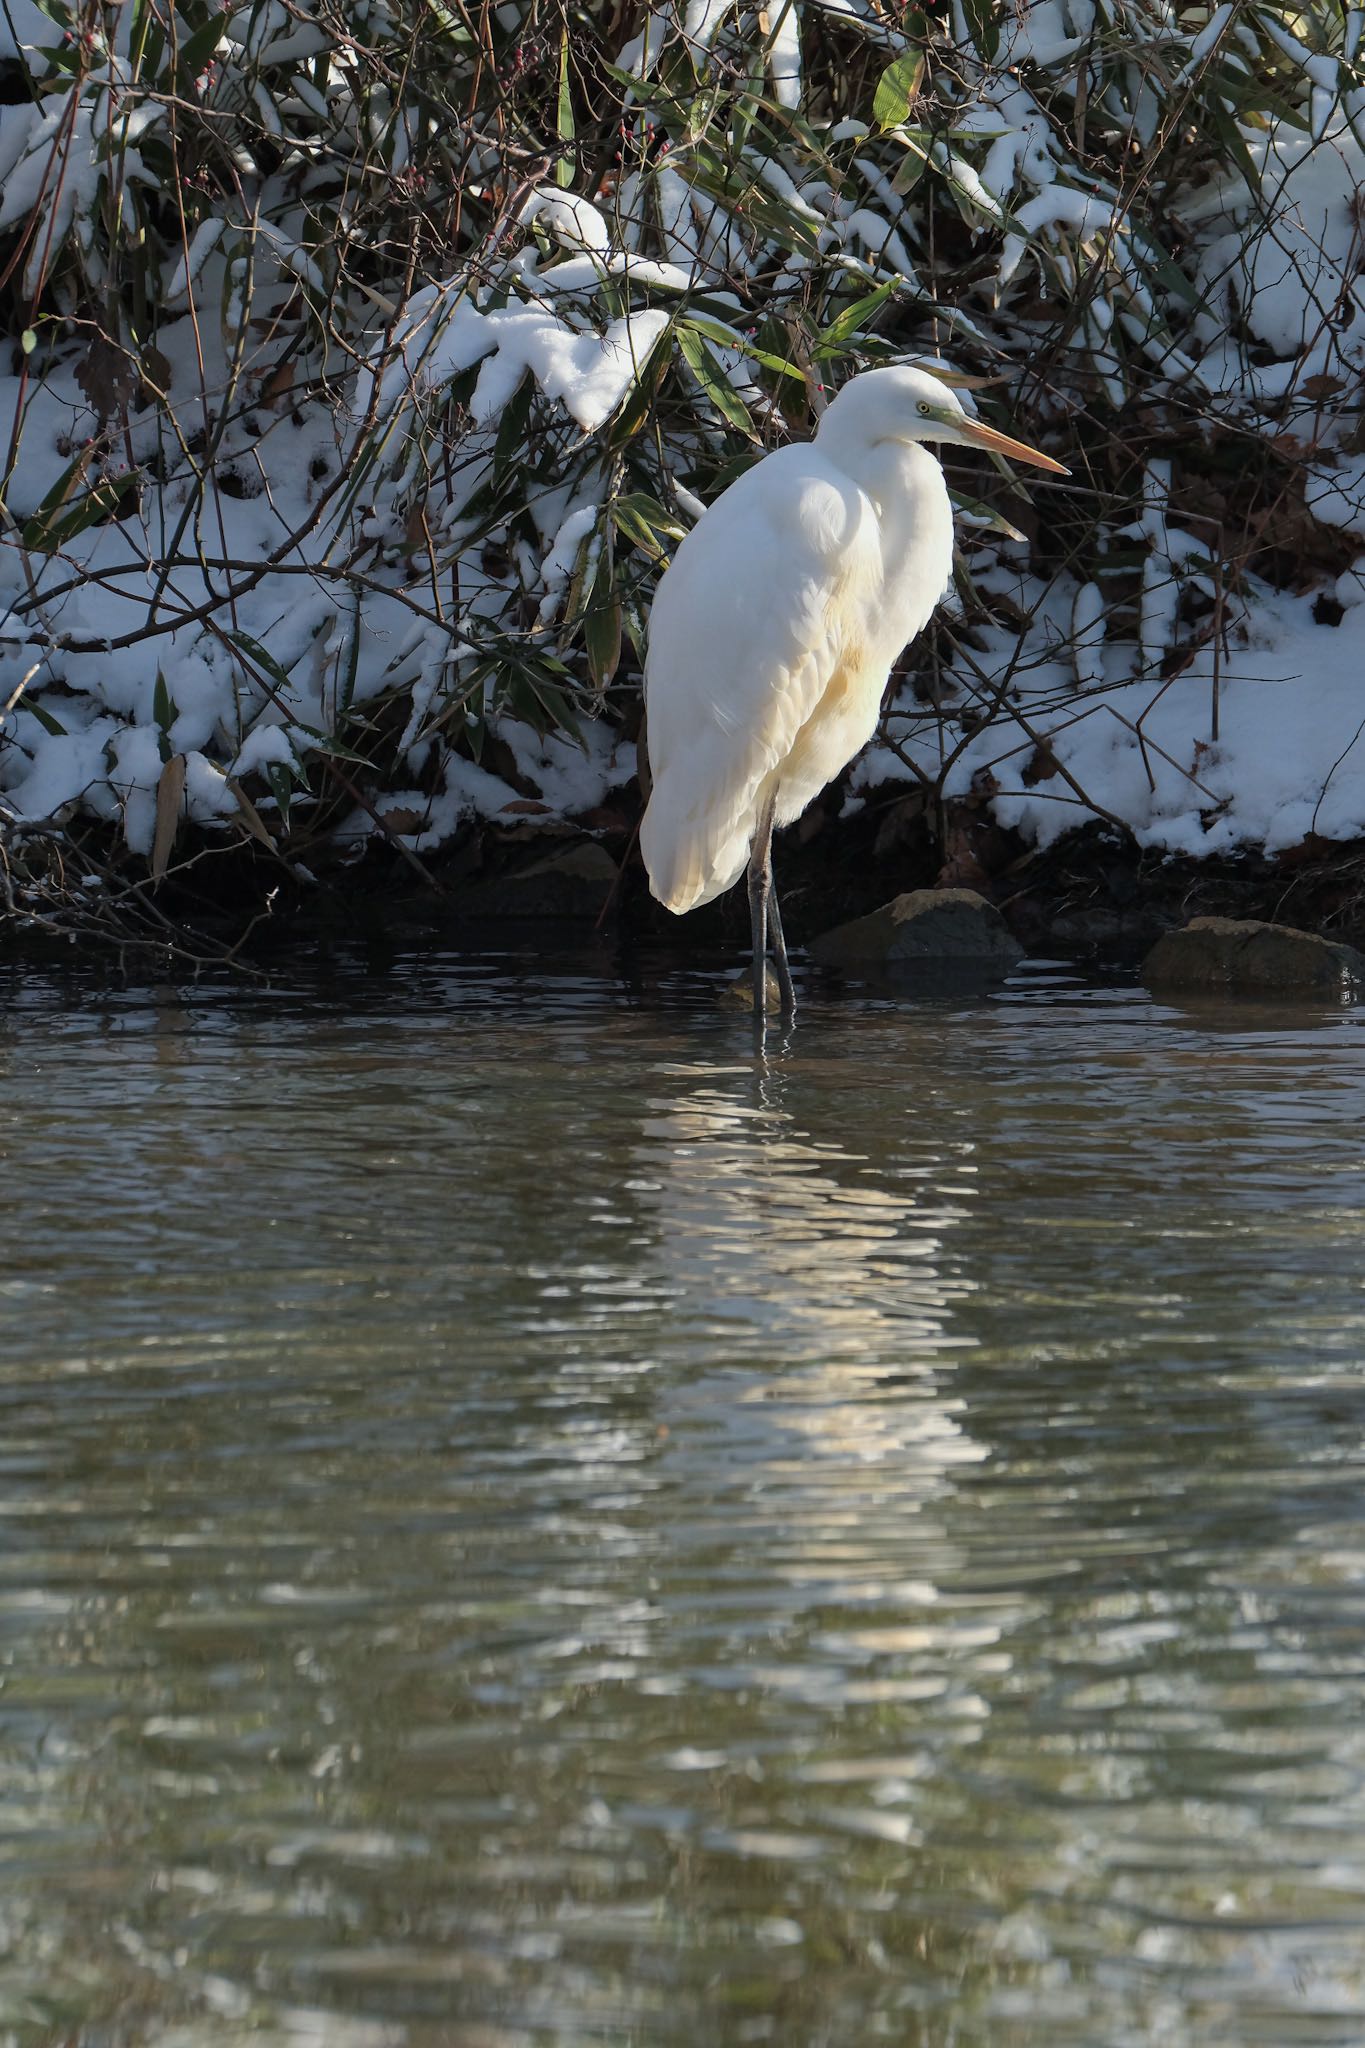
641,365 -> 1068,1022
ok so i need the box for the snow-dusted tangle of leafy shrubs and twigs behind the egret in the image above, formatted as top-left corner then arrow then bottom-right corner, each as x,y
0,0 -> 1365,913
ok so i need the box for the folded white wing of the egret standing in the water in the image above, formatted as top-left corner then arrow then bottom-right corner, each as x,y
641,446 -> 880,911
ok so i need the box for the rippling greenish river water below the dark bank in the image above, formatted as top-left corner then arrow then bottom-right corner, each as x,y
0,958 -> 1365,2048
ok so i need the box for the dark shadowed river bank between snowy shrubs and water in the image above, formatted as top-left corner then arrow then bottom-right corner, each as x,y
0,784 -> 1365,971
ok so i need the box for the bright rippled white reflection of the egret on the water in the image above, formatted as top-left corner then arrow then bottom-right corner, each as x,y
636,1063 -> 986,1495
